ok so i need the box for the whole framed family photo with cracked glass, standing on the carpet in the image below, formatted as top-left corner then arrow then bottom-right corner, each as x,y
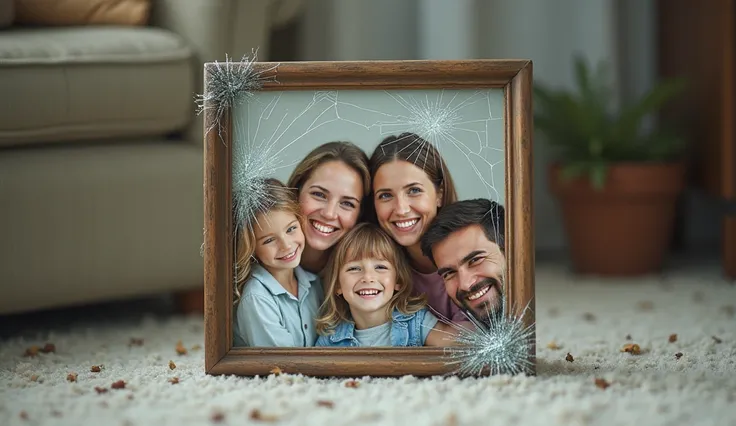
203,60 -> 534,376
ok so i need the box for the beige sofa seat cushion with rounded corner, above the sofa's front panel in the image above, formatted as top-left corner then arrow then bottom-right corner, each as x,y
0,26 -> 195,147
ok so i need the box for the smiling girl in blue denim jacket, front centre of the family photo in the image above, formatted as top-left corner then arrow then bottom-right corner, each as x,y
315,222 -> 453,347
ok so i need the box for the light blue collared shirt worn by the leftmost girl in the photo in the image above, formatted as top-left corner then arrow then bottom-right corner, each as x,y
233,265 -> 324,347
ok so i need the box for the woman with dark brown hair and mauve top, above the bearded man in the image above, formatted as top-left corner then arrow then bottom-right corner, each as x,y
370,133 -> 467,322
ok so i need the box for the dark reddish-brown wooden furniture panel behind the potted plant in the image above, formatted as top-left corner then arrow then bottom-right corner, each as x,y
657,0 -> 736,198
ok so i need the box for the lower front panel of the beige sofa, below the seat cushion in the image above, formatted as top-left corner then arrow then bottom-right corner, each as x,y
0,138 -> 204,314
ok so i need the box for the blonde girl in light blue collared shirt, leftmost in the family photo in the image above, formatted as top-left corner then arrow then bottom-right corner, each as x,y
233,179 -> 324,347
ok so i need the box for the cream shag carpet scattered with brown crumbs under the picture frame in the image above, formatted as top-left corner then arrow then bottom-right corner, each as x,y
0,264 -> 736,426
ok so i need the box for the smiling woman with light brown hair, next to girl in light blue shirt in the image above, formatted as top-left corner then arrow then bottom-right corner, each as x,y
287,142 -> 370,274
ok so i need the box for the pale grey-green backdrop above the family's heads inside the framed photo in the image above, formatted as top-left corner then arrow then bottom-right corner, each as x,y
233,89 -> 506,205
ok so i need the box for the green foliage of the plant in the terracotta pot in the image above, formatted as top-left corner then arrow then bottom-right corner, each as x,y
533,56 -> 686,167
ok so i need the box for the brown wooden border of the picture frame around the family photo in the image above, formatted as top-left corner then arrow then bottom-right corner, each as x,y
203,59 -> 536,377
